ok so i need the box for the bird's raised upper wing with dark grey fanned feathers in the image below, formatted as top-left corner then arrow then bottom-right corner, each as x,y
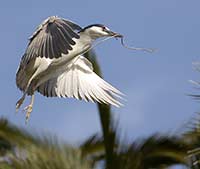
22,16 -> 82,63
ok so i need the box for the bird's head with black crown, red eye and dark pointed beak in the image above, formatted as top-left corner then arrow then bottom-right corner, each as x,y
81,24 -> 122,39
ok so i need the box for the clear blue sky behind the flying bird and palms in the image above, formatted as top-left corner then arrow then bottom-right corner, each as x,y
0,0 -> 200,151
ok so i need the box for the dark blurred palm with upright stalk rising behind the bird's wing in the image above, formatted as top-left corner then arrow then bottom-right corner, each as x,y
81,51 -> 188,169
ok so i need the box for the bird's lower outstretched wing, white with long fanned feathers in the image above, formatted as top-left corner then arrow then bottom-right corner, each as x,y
37,56 -> 122,107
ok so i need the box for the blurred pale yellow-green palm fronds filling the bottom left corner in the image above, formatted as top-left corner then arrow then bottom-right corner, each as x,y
0,119 -> 92,169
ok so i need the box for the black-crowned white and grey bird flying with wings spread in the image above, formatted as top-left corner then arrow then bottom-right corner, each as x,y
16,16 -> 123,121
